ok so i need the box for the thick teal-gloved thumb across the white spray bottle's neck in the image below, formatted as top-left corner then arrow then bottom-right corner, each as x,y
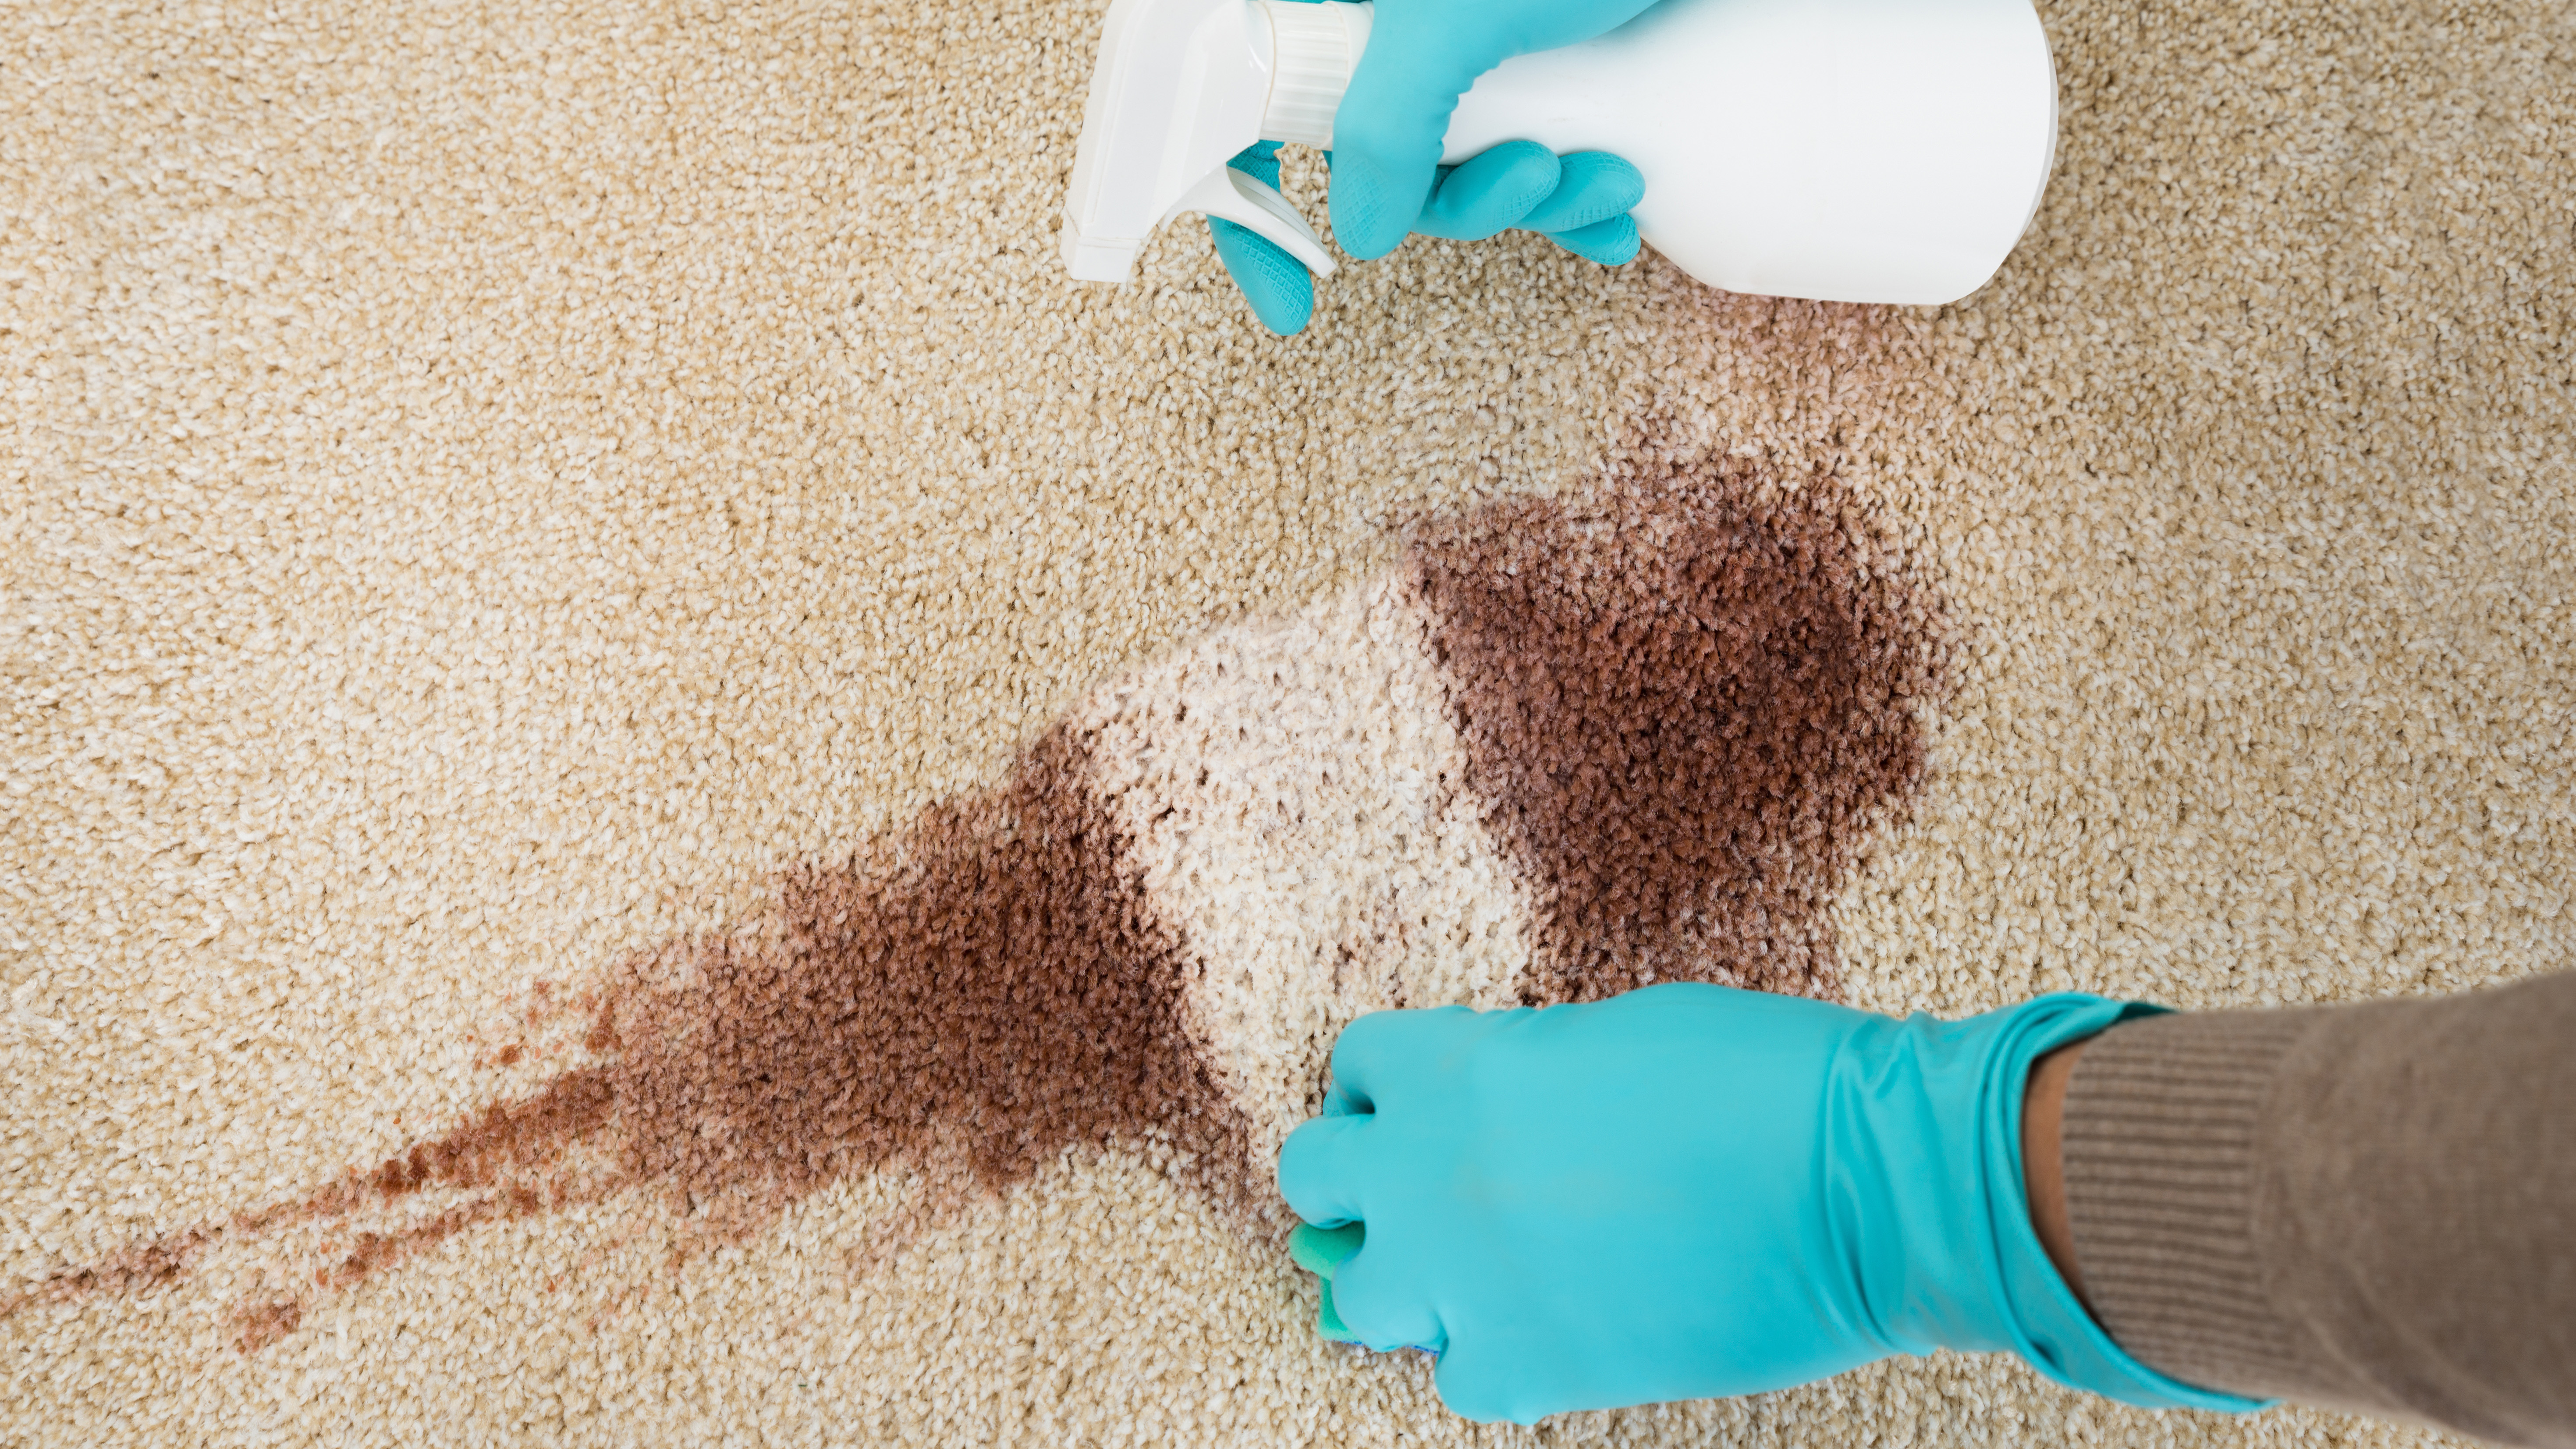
1332,16 -> 1502,260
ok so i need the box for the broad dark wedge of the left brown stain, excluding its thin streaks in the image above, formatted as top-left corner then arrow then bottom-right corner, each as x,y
600,727 -> 1244,1209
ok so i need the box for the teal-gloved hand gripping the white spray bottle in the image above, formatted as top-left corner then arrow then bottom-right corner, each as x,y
1208,0 -> 1651,335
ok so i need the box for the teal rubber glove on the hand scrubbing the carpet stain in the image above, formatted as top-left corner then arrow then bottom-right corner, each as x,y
1280,985 -> 2262,1423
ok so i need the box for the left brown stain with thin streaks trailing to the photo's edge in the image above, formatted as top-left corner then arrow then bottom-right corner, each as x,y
0,730 -> 1249,1351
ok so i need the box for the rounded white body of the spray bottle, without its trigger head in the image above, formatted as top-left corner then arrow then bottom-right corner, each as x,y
1443,0 -> 2058,304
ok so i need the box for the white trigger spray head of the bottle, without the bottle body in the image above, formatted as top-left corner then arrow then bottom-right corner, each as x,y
1064,0 -> 1376,281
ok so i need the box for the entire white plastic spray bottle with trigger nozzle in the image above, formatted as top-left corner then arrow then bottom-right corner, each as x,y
1064,0 -> 2058,304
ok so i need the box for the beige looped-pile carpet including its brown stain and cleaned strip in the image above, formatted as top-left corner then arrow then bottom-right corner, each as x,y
0,0 -> 2576,1446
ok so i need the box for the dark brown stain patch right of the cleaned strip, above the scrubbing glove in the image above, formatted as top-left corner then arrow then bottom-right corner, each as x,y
1414,459 -> 1942,1003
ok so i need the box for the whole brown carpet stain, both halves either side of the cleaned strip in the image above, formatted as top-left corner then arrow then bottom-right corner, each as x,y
0,451 -> 1940,1351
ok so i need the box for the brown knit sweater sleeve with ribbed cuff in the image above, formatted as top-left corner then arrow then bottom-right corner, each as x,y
2063,972 -> 2576,1446
